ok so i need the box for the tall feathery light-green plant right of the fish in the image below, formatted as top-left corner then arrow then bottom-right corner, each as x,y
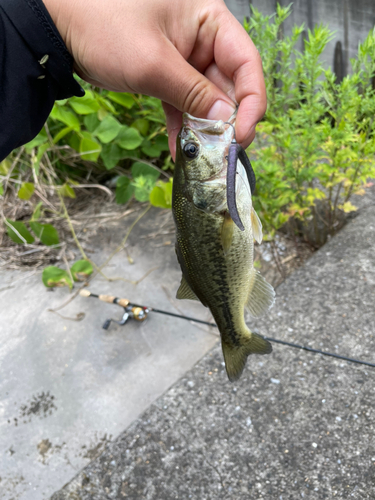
245,5 -> 375,246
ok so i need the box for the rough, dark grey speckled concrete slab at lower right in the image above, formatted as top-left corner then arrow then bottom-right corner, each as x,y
51,185 -> 375,500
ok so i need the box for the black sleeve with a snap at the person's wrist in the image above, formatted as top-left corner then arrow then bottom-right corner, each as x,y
0,0 -> 84,161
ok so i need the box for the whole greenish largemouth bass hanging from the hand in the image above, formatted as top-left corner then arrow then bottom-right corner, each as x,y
172,113 -> 275,382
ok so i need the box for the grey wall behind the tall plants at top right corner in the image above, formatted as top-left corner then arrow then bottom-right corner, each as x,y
225,0 -> 375,74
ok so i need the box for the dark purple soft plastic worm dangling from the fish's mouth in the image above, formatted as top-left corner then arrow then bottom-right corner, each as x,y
226,122 -> 256,231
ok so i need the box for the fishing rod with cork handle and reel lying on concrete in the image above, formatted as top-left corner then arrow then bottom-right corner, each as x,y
79,290 -> 375,368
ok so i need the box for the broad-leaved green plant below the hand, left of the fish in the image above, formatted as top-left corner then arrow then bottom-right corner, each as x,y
0,84 -> 173,215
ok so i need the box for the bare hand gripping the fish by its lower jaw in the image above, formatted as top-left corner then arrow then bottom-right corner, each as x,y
44,0 -> 266,157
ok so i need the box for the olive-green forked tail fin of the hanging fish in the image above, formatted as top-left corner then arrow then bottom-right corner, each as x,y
221,332 -> 272,382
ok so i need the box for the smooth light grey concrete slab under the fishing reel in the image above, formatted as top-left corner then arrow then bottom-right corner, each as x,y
0,209 -> 218,500
